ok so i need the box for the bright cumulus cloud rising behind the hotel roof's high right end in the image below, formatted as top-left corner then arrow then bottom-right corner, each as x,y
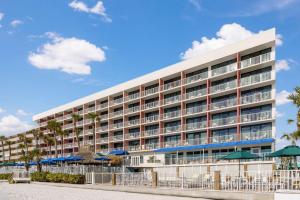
180,23 -> 282,60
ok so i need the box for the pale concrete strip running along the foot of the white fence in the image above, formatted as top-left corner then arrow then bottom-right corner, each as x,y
33,182 -> 274,200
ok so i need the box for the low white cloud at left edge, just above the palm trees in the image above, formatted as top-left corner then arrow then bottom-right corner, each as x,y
0,115 -> 34,136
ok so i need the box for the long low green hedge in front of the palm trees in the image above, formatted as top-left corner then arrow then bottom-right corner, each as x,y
31,172 -> 85,184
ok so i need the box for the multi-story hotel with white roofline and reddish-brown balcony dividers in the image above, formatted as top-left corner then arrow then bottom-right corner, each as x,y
0,29 -> 275,166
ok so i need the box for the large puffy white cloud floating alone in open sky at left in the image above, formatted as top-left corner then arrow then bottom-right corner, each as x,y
28,32 -> 106,75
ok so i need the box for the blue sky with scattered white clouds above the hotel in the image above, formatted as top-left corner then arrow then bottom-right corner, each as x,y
0,0 -> 300,147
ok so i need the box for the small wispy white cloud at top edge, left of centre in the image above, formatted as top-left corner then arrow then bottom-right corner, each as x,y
69,0 -> 112,22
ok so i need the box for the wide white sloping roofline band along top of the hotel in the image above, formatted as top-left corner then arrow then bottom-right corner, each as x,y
33,28 -> 276,121
